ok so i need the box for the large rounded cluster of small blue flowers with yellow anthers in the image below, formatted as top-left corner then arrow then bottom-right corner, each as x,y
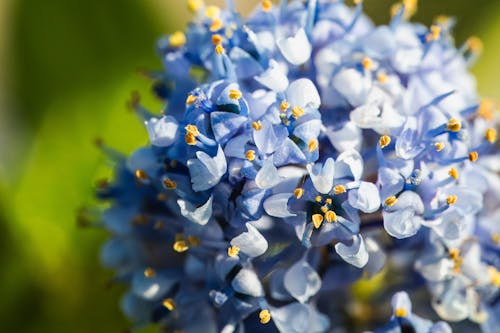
93,0 -> 500,333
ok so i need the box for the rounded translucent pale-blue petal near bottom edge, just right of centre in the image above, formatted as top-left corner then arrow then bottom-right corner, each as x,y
284,260 -> 321,303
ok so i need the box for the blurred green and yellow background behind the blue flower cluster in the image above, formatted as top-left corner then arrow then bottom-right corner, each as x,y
0,0 -> 500,333
